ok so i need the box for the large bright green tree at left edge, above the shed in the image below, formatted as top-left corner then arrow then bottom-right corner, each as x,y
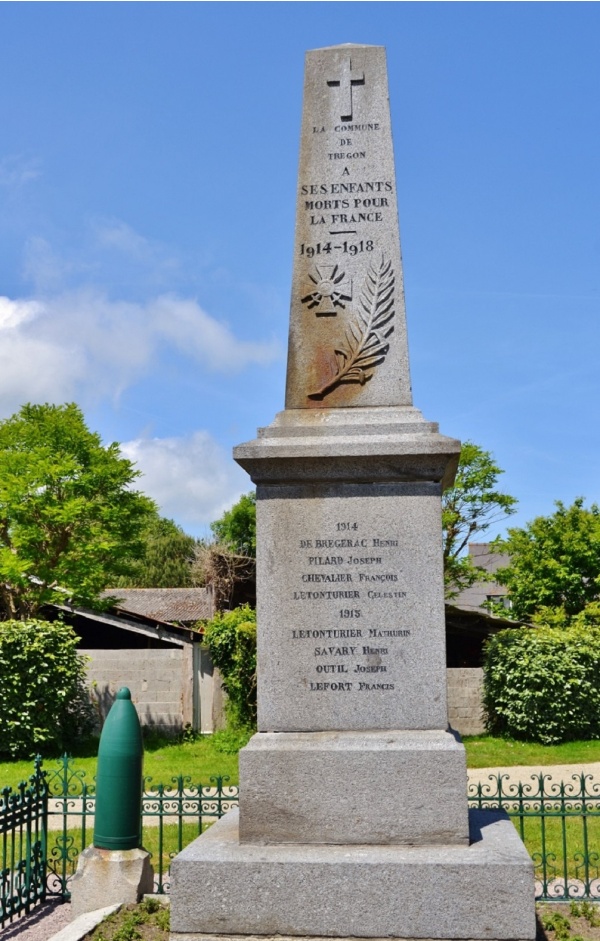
0,404 -> 156,619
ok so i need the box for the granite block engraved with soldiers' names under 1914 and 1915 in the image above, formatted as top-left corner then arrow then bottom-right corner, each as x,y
257,482 -> 447,732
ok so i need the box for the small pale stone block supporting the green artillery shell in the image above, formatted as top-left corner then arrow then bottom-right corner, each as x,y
70,846 -> 154,918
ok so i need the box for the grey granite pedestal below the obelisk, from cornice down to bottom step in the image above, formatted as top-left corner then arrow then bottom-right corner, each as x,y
171,409 -> 536,941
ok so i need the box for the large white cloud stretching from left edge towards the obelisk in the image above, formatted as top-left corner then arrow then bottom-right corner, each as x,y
0,289 -> 280,415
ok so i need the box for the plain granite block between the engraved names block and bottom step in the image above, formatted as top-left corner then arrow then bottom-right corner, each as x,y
240,731 -> 469,845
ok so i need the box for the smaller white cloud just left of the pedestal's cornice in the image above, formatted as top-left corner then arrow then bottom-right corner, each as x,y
120,431 -> 247,534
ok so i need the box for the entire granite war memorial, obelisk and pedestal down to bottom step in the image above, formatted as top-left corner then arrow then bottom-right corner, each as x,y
171,45 -> 536,941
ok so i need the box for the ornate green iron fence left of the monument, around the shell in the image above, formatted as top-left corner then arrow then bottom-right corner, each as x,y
0,755 -> 238,927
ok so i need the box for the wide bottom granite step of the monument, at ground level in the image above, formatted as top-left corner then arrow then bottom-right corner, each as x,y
171,811 -> 536,941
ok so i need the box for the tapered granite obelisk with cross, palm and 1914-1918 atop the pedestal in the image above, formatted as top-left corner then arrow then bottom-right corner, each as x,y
286,44 -> 412,409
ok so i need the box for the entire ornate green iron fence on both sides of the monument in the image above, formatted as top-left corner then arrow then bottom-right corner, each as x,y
0,755 -> 600,926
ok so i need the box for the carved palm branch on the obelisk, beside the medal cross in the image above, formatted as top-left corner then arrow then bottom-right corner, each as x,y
309,255 -> 394,399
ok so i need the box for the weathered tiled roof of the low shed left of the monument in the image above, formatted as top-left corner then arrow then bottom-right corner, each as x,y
104,588 -> 214,624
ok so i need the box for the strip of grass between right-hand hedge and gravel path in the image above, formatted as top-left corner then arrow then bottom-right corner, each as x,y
463,735 -> 600,768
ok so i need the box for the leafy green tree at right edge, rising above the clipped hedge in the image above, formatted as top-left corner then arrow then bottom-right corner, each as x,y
495,497 -> 600,626
